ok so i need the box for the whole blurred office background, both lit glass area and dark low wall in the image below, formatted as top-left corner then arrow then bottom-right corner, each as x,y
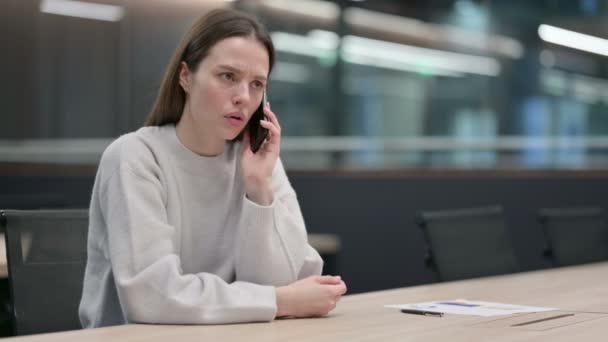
0,0 -> 608,300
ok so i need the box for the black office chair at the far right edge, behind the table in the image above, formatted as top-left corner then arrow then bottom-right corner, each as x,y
539,207 -> 608,266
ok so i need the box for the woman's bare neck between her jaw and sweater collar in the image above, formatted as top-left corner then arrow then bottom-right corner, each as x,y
175,104 -> 225,157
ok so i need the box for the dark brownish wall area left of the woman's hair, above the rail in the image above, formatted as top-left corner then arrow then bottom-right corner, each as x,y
0,0 -> 228,139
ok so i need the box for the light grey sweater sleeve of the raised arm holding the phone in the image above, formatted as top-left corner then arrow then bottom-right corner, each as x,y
236,160 -> 323,286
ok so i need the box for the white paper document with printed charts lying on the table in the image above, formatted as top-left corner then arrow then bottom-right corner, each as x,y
385,299 -> 556,317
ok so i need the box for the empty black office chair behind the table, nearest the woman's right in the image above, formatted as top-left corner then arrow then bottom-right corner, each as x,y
417,206 -> 519,281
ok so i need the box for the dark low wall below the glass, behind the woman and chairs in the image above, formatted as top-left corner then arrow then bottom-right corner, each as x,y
0,167 -> 608,293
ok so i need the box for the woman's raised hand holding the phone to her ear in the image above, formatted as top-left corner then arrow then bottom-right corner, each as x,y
241,105 -> 281,205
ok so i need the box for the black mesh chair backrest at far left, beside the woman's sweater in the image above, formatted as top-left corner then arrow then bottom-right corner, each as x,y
0,209 -> 88,335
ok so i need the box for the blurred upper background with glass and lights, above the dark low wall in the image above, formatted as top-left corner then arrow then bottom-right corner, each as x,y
0,0 -> 608,170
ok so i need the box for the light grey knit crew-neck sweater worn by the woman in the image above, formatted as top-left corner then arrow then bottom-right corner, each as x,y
79,125 -> 323,327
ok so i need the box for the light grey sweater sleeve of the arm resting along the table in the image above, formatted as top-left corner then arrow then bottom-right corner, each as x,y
99,149 -> 276,324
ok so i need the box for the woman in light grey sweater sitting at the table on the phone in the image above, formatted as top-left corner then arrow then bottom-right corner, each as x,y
79,9 -> 346,327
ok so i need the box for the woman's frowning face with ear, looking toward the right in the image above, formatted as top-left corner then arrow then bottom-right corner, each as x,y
180,37 -> 269,140
